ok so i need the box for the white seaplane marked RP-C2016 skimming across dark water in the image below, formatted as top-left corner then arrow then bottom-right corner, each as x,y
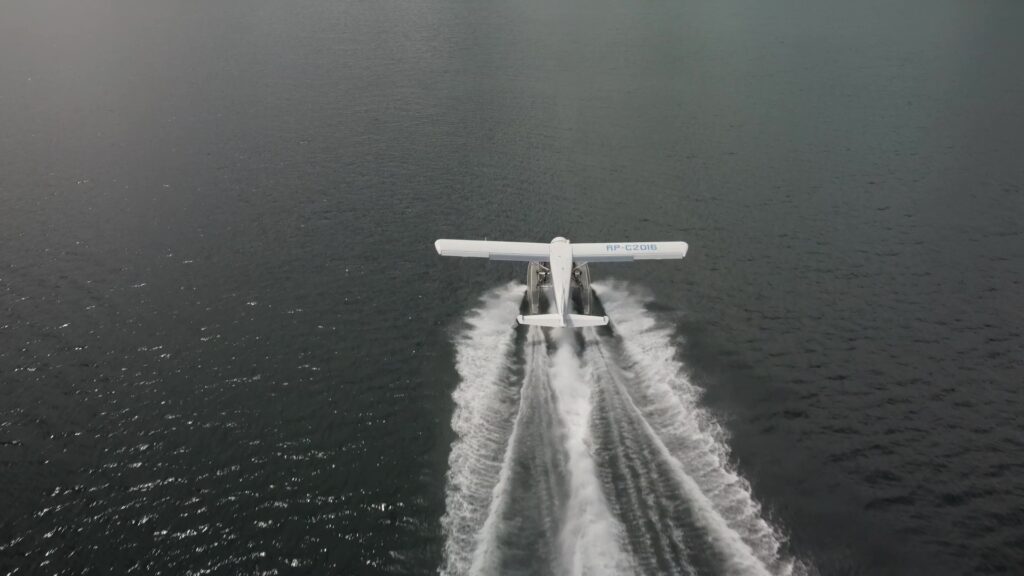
434,236 -> 688,328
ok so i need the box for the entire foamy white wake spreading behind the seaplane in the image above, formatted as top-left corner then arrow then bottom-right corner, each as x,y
440,282 -> 808,576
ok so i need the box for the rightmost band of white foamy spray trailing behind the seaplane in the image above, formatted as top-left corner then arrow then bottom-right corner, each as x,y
592,283 -> 806,575
